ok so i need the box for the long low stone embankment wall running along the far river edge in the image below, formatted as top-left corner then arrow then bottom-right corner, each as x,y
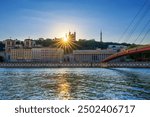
0,62 -> 150,68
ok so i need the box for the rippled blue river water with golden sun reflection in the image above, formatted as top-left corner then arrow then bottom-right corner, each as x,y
0,68 -> 150,100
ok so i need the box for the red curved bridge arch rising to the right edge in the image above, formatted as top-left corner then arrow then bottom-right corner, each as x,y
102,45 -> 150,62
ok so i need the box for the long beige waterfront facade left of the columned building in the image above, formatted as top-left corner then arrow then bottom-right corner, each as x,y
10,48 -> 64,63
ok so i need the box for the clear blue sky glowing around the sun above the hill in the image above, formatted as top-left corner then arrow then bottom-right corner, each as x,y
0,0 -> 150,43
